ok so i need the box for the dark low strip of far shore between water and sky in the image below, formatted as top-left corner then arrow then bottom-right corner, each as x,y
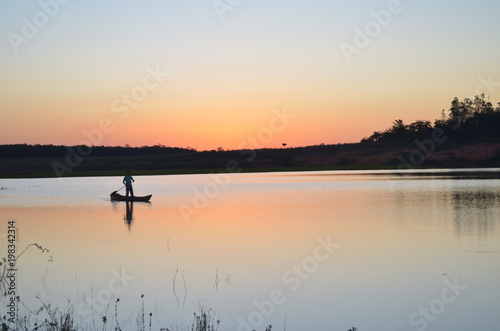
0,141 -> 500,178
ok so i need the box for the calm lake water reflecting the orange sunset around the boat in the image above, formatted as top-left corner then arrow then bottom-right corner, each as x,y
0,169 -> 500,331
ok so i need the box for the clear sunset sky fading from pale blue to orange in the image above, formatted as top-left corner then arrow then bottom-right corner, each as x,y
0,0 -> 500,150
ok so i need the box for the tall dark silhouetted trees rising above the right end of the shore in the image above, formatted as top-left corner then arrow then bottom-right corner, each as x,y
361,94 -> 500,144
